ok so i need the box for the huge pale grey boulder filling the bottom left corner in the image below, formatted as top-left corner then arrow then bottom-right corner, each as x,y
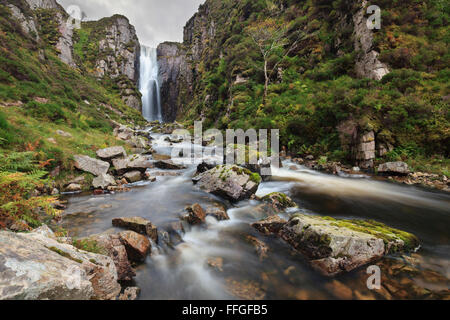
0,231 -> 121,300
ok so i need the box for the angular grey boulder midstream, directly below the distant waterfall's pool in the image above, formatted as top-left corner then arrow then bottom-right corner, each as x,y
192,165 -> 261,202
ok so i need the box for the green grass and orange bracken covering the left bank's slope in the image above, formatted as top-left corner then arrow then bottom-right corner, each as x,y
0,1 -> 143,228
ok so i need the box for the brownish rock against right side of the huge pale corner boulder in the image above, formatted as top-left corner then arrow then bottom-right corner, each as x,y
78,233 -> 136,281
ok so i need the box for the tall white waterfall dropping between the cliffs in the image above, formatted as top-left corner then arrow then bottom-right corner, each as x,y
139,45 -> 162,122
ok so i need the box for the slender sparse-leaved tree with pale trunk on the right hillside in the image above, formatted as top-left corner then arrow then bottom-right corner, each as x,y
247,18 -> 299,104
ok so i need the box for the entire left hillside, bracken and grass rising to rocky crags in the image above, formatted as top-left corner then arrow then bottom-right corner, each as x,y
0,0 -> 145,227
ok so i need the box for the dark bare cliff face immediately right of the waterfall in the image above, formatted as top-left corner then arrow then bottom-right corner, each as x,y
157,42 -> 193,122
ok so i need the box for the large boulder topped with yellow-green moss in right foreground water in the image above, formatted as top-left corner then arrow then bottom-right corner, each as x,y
279,214 -> 419,276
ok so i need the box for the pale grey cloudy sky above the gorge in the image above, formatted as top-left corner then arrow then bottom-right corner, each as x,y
57,0 -> 205,47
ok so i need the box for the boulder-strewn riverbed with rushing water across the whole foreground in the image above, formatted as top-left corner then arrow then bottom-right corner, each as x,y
0,127 -> 450,300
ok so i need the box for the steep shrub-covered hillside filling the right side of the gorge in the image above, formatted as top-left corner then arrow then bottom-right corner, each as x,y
158,0 -> 450,174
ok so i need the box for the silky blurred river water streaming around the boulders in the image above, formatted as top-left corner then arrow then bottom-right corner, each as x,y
64,131 -> 450,300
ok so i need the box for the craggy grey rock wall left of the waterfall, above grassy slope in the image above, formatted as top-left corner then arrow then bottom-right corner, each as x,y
2,0 -> 142,111
